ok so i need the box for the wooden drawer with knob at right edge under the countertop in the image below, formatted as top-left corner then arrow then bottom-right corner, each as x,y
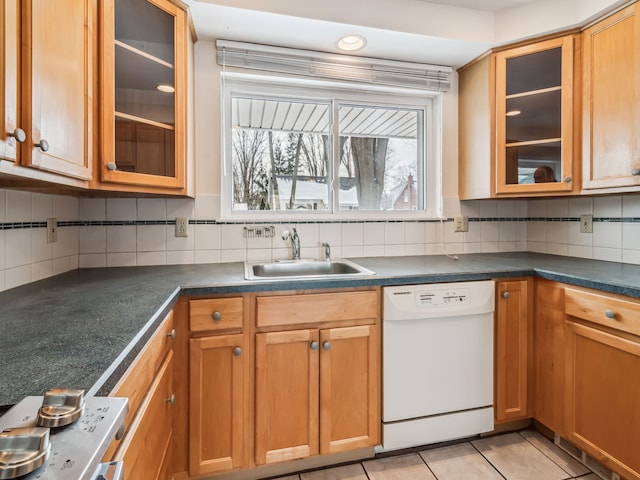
564,288 -> 640,335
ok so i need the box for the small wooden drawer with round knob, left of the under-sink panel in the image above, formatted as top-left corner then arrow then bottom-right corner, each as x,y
189,297 -> 244,332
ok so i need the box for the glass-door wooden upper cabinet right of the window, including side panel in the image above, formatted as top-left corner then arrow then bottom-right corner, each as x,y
458,35 -> 581,200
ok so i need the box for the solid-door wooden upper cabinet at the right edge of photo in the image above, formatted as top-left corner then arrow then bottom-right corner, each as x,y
582,3 -> 640,191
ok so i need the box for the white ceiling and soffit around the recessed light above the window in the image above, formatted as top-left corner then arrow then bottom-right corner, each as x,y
185,0 -> 627,68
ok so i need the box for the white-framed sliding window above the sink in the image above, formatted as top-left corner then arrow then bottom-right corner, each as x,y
222,74 -> 441,219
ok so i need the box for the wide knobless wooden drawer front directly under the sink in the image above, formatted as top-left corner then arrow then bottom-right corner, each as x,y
257,291 -> 378,327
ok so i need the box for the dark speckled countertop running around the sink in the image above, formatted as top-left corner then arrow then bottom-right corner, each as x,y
0,253 -> 640,405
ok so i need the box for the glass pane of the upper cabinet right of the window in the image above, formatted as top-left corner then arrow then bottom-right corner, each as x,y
505,47 -> 562,184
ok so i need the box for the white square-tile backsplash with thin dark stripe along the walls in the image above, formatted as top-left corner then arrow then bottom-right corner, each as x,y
0,189 -> 640,291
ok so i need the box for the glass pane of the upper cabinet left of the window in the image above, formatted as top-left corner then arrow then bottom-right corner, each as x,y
114,0 -> 175,176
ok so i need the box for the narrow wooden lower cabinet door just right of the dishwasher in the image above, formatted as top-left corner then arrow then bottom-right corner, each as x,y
494,279 -> 533,423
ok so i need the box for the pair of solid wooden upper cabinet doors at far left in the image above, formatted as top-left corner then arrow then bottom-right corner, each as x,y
0,0 -> 96,186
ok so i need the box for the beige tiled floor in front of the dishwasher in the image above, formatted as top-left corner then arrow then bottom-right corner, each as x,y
278,430 -> 599,480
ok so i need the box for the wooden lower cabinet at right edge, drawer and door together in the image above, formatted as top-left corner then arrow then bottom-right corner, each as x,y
564,287 -> 640,480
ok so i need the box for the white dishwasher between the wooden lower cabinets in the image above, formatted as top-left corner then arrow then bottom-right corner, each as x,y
382,281 -> 495,451
